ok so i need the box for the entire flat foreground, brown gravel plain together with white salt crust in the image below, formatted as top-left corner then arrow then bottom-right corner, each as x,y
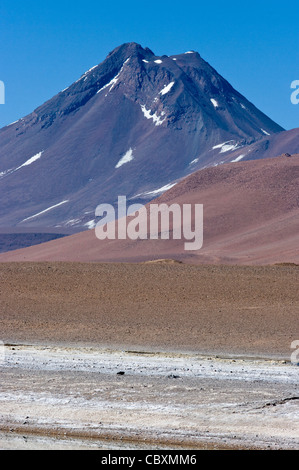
0,262 -> 299,449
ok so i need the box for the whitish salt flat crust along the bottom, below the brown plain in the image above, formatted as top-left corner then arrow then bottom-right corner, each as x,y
0,345 -> 299,449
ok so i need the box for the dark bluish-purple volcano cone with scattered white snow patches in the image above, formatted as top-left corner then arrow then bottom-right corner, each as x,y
0,43 -> 283,231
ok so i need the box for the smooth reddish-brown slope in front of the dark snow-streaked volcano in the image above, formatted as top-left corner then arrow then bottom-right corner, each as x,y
0,155 -> 299,264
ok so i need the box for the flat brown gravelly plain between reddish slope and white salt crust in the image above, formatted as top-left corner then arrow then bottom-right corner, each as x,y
0,263 -> 299,359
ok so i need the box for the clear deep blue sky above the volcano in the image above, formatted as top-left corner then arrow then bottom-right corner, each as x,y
0,0 -> 299,129
